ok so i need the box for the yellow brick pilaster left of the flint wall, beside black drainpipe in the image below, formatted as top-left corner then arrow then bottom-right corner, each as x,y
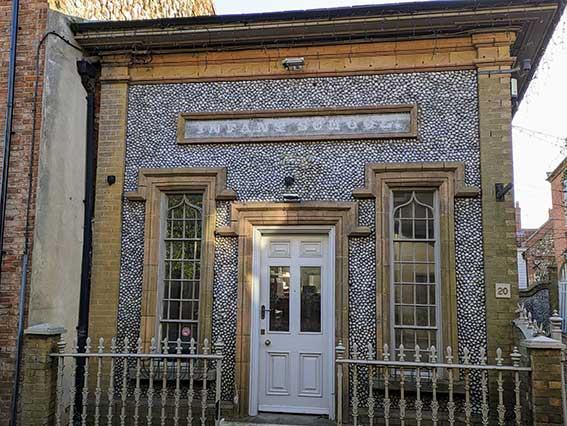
89,66 -> 128,347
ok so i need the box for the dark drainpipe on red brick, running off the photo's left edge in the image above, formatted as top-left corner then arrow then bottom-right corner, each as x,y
0,0 -> 20,283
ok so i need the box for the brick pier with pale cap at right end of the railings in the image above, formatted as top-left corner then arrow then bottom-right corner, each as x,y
521,336 -> 566,426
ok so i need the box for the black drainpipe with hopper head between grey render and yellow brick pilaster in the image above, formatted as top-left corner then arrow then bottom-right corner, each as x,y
75,59 -> 99,416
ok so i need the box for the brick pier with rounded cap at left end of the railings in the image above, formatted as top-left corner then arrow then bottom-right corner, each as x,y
21,324 -> 65,426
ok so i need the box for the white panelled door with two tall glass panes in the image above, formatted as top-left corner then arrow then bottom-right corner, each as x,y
258,235 -> 333,414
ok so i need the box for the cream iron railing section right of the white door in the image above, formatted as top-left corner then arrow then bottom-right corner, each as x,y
336,342 -> 531,426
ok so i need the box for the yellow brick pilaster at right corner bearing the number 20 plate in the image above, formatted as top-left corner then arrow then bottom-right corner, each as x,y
474,33 -> 518,359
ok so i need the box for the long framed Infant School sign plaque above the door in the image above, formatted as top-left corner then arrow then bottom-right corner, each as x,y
178,105 -> 417,144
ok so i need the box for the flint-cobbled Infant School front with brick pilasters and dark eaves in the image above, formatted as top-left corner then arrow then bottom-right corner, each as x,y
65,1 -> 561,417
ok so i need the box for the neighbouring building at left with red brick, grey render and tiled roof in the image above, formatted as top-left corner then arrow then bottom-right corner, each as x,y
0,0 -> 214,425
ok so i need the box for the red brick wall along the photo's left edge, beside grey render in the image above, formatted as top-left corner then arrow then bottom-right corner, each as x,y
0,0 -> 47,426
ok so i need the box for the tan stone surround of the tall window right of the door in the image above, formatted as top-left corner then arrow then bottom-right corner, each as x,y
353,162 -> 479,355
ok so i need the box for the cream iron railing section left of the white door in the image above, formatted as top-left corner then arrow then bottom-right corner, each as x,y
51,338 -> 224,426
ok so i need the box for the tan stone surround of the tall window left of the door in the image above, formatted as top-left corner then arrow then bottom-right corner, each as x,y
125,168 -> 236,351
